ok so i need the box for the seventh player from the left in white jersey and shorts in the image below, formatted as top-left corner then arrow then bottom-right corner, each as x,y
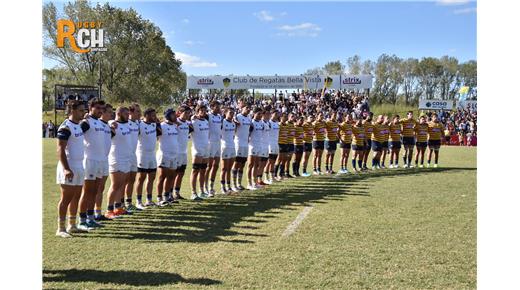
155,109 -> 179,206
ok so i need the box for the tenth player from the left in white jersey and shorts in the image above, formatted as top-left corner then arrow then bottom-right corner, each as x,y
204,101 -> 223,197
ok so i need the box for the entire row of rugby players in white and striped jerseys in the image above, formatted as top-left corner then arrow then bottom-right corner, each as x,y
56,99 -> 444,238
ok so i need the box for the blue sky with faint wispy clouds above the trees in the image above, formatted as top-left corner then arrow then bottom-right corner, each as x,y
44,0 -> 477,75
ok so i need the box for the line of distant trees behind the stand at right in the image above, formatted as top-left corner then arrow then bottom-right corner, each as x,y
305,54 -> 477,105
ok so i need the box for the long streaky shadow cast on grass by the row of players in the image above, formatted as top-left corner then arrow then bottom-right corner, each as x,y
85,167 -> 476,243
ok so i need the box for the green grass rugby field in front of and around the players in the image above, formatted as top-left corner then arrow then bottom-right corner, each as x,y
43,140 -> 477,289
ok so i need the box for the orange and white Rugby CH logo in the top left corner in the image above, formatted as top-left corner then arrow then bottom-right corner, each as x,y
56,19 -> 107,53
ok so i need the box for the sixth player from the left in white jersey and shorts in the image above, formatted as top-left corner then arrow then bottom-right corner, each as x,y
136,108 -> 162,210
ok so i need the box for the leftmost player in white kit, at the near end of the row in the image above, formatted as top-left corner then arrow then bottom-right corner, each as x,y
56,100 -> 85,238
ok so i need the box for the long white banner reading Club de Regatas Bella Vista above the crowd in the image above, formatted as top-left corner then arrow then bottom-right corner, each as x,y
186,75 -> 372,90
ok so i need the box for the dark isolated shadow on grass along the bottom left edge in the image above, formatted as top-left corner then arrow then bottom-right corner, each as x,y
43,269 -> 222,287
